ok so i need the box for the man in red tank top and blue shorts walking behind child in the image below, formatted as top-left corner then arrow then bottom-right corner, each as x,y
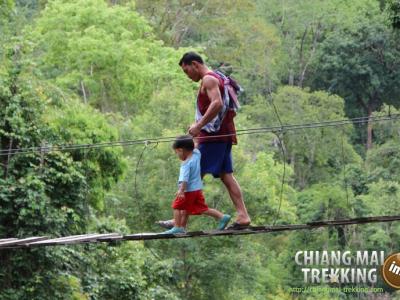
159,52 -> 251,229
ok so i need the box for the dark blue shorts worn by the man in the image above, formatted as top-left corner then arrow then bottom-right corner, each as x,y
199,142 -> 233,178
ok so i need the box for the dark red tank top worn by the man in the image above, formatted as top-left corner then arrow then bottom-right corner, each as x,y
197,72 -> 237,145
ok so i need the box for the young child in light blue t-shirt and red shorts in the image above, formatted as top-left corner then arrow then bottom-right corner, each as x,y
163,135 -> 231,234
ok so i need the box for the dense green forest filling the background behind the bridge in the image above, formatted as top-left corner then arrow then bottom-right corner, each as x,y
0,0 -> 400,300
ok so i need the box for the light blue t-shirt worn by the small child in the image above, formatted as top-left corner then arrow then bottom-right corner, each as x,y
178,149 -> 203,192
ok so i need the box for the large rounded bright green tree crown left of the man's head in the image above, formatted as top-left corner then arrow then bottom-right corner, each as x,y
27,0 -> 183,113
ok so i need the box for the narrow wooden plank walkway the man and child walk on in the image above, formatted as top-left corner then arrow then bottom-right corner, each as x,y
0,215 -> 400,250
